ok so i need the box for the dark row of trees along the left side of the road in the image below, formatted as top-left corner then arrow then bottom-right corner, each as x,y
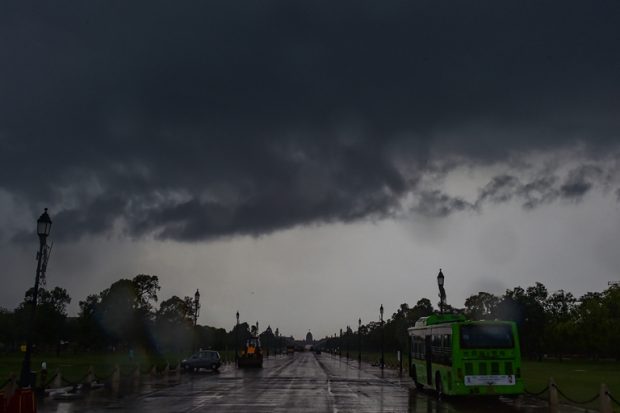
0,274 -> 291,354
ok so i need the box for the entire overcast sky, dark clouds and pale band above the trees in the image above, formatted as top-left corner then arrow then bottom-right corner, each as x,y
0,0 -> 620,337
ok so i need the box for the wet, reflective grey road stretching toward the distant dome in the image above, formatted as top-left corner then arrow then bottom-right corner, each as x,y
39,353 -> 580,413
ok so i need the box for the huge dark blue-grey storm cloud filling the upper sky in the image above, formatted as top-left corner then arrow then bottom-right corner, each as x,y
0,1 -> 620,240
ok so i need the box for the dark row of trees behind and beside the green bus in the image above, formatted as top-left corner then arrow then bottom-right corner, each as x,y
323,282 -> 620,359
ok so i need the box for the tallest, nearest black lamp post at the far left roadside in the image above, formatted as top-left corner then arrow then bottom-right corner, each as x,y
19,208 -> 52,387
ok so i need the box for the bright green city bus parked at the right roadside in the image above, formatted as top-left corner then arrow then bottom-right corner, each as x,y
407,314 -> 523,396
